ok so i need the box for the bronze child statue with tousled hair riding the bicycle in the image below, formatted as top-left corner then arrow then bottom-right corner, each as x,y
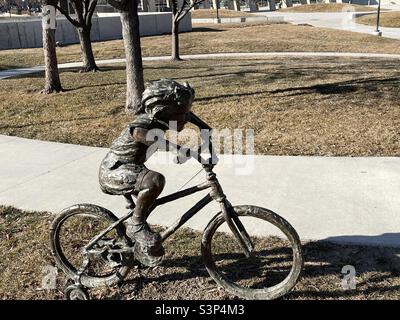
99,79 -> 209,266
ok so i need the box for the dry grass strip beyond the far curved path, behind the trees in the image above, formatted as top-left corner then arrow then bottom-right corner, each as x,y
0,24 -> 400,70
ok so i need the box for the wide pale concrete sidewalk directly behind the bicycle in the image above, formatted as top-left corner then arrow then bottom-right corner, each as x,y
0,135 -> 400,247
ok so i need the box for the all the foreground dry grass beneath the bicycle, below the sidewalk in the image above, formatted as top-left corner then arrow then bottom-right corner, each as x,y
0,206 -> 400,300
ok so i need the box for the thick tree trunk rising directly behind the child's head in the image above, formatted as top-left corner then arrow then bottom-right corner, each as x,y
121,0 -> 144,113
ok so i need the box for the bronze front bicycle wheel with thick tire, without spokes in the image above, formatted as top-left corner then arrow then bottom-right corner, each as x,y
201,206 -> 303,300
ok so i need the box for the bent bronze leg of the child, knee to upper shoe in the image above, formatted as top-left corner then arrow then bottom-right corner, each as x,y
128,171 -> 165,243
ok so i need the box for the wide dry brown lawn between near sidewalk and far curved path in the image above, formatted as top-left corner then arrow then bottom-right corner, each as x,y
0,58 -> 400,156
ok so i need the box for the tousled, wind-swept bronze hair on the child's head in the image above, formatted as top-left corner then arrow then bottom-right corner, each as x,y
137,79 -> 194,118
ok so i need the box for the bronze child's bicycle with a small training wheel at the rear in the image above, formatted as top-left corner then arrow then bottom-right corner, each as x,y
50,138 -> 303,300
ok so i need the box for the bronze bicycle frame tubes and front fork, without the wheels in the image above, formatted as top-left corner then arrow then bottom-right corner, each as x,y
85,165 -> 254,257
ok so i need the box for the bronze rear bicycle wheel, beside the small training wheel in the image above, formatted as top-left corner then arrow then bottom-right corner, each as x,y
50,204 -> 129,288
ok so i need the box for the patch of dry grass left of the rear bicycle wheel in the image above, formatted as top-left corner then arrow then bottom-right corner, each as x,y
0,206 -> 62,300
